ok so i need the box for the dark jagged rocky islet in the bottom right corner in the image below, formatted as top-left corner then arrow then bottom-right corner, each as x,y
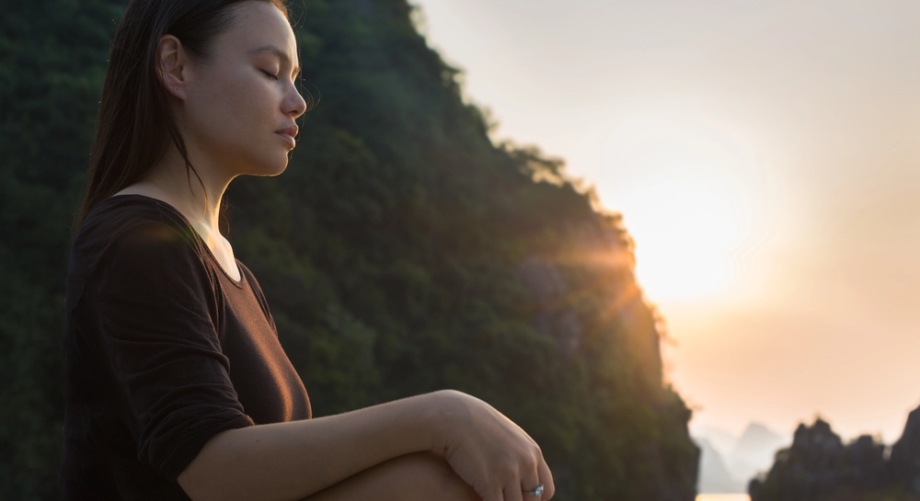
748,402 -> 920,501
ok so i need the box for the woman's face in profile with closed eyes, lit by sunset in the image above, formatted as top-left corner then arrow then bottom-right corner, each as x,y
176,1 -> 306,178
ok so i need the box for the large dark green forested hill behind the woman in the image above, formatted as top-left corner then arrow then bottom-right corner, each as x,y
0,0 -> 697,501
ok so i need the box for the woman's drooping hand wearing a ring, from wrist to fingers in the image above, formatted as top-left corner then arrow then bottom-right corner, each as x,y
434,391 -> 555,501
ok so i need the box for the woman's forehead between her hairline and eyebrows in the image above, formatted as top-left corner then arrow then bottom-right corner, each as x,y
215,1 -> 297,64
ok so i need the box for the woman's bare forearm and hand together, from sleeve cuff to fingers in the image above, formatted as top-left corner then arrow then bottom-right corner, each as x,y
178,391 -> 553,501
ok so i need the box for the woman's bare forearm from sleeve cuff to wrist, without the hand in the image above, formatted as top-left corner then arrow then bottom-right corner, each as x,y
179,392 -> 450,501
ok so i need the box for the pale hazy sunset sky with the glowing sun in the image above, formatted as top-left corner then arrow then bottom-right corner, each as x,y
411,0 -> 920,443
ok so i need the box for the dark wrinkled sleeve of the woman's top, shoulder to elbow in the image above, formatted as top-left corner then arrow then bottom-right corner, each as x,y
76,223 -> 253,479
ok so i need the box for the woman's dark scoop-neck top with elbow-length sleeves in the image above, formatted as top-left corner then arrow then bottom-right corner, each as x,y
61,195 -> 311,500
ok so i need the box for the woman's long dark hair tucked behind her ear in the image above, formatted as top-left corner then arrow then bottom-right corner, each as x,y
74,0 -> 288,230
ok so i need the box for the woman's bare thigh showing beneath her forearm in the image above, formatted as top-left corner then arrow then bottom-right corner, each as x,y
304,453 -> 482,501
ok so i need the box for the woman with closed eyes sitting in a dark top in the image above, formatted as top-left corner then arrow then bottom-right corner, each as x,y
62,0 -> 553,501
